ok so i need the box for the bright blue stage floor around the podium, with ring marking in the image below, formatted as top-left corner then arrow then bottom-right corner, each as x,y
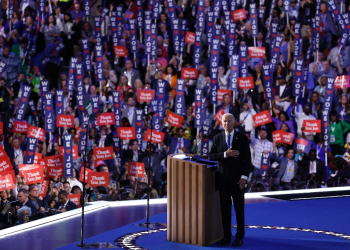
59,198 -> 350,250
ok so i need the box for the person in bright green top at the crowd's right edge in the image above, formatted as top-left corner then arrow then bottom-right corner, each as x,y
328,110 -> 350,156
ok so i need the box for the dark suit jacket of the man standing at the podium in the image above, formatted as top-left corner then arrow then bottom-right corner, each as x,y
209,131 -> 252,185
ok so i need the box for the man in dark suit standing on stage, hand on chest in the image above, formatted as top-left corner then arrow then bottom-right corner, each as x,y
209,114 -> 251,246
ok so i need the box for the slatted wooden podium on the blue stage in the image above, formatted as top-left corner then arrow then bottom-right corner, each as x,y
167,155 -> 224,246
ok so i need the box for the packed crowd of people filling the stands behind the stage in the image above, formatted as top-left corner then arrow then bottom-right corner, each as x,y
0,0 -> 350,228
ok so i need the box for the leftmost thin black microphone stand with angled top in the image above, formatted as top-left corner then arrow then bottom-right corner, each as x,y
76,105 -> 112,249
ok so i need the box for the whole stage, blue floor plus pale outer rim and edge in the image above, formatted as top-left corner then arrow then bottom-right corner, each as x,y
0,188 -> 350,250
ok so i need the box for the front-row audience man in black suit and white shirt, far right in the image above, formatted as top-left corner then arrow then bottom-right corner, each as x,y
299,149 -> 326,185
